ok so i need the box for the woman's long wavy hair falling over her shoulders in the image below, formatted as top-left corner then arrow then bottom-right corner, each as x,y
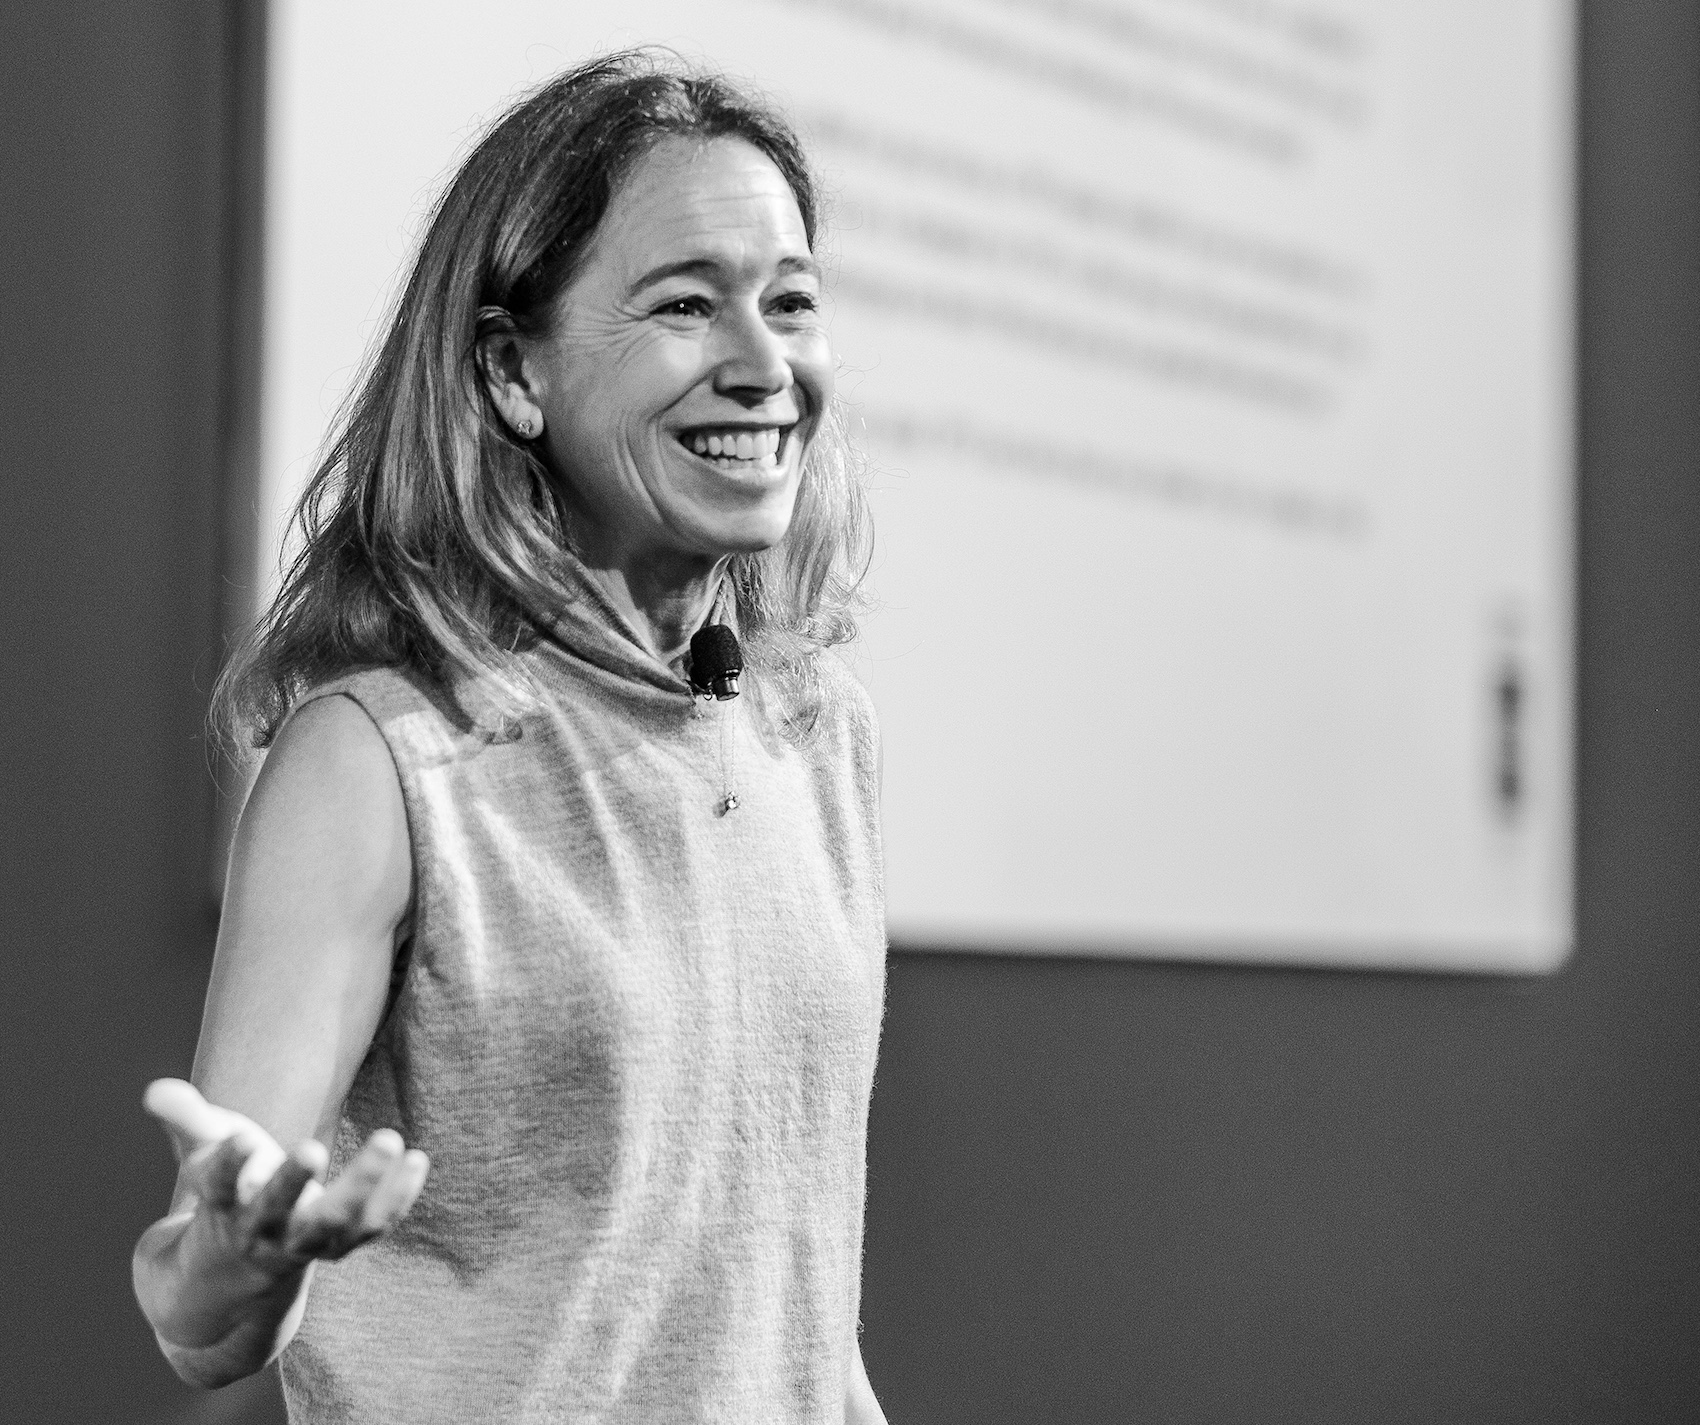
213,51 -> 870,750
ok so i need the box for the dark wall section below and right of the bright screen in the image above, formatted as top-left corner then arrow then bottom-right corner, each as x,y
864,0 -> 1700,1425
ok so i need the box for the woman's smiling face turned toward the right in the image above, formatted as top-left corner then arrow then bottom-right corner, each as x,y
522,138 -> 833,571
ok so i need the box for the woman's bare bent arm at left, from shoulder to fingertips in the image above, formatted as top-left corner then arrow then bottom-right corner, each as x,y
134,699 -> 427,1384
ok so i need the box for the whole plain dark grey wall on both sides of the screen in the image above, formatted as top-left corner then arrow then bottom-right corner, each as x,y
0,0 -> 1700,1425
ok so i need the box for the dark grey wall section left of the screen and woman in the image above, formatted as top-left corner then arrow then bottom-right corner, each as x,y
0,0 -> 253,1422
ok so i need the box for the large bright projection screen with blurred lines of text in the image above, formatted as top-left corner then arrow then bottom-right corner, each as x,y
257,0 -> 1574,971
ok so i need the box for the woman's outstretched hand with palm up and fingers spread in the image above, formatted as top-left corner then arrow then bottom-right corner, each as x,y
143,1078 -> 430,1280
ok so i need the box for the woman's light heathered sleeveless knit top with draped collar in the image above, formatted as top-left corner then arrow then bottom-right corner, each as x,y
282,582 -> 886,1425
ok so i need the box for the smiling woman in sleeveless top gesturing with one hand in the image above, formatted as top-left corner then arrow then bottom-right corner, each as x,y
134,54 -> 884,1425
